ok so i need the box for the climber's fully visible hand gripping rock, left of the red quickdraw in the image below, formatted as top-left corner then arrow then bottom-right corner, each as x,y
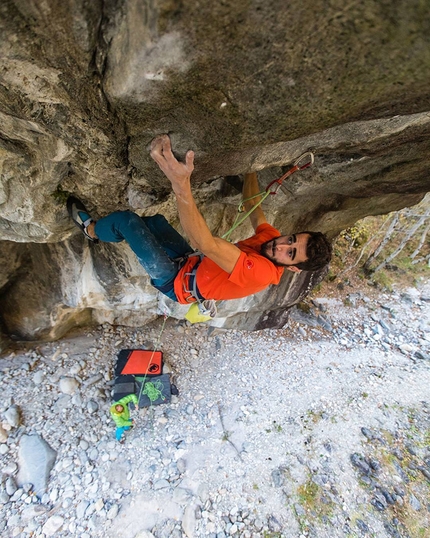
151,135 -> 194,193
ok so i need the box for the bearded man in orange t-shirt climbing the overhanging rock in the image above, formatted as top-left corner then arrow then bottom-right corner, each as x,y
67,135 -> 331,304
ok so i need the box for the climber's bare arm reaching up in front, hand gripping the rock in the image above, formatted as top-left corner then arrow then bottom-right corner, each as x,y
151,135 -> 240,273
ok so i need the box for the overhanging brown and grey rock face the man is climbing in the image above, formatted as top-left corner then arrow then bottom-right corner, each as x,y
0,0 -> 430,342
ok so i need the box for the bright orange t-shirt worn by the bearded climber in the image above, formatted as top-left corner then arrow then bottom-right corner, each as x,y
174,223 -> 284,304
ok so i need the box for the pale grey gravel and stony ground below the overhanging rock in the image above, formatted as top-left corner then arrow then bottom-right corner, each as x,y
0,274 -> 430,538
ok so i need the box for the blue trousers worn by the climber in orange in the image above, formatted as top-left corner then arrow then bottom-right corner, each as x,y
95,211 -> 193,301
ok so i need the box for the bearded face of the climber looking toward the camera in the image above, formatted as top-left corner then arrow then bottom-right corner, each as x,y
261,234 -> 310,271
